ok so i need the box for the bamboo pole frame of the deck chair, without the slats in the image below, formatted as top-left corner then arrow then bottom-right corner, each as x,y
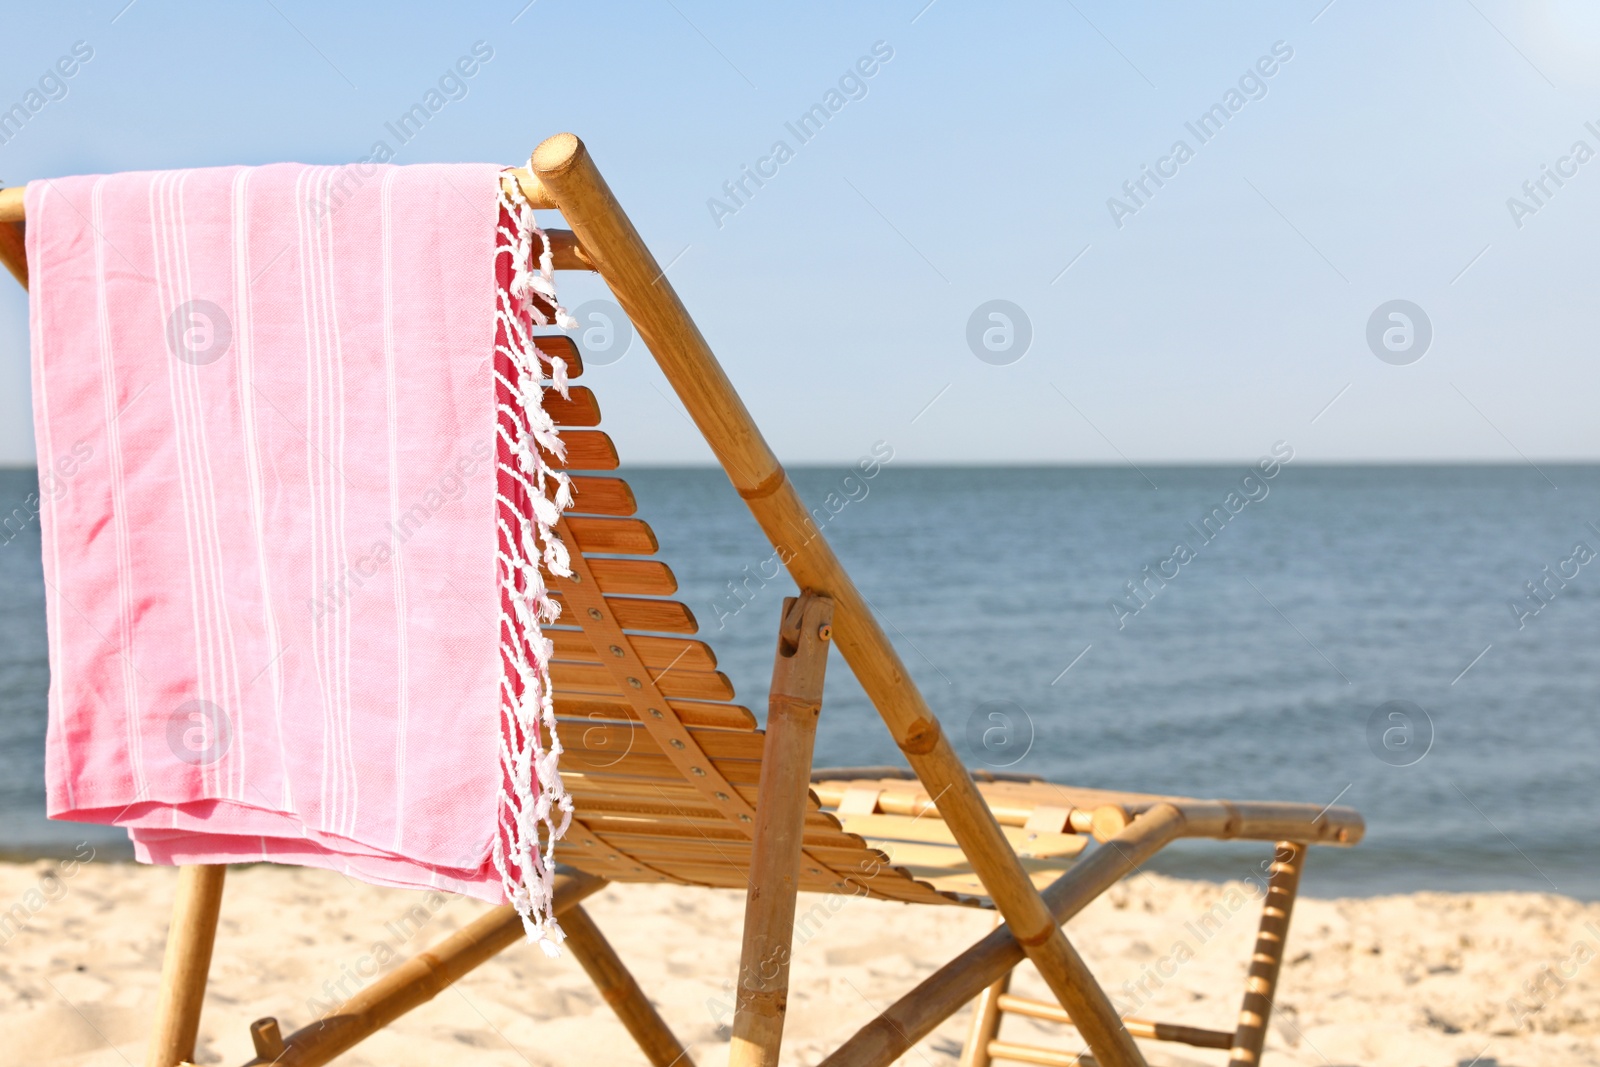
0,134 -> 1363,1067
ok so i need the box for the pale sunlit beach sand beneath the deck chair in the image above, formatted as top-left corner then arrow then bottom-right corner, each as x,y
0,861 -> 1600,1067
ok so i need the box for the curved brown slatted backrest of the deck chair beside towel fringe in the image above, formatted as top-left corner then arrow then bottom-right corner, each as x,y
538,329 -> 974,904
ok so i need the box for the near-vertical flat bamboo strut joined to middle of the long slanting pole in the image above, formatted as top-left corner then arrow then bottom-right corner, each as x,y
728,593 -> 834,1067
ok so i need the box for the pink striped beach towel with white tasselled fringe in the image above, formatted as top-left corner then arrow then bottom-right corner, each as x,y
27,163 -> 571,949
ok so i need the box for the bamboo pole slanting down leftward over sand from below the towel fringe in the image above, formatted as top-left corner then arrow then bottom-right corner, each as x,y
249,870 -> 605,1067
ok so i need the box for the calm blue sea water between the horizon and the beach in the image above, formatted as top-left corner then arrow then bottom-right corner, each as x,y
0,462 -> 1600,899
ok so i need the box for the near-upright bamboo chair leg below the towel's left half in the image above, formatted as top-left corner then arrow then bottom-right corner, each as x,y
144,865 -> 227,1067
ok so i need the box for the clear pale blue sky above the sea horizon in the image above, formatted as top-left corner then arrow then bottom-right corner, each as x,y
0,0 -> 1600,462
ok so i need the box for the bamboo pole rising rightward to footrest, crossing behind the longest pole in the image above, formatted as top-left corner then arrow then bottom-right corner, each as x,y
819,805 -> 1184,1067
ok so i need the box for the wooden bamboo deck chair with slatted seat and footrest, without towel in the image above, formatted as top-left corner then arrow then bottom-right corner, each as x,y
0,134 -> 1363,1067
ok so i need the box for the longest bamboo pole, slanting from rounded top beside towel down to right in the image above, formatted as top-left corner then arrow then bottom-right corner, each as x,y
530,133 -> 1144,1067
